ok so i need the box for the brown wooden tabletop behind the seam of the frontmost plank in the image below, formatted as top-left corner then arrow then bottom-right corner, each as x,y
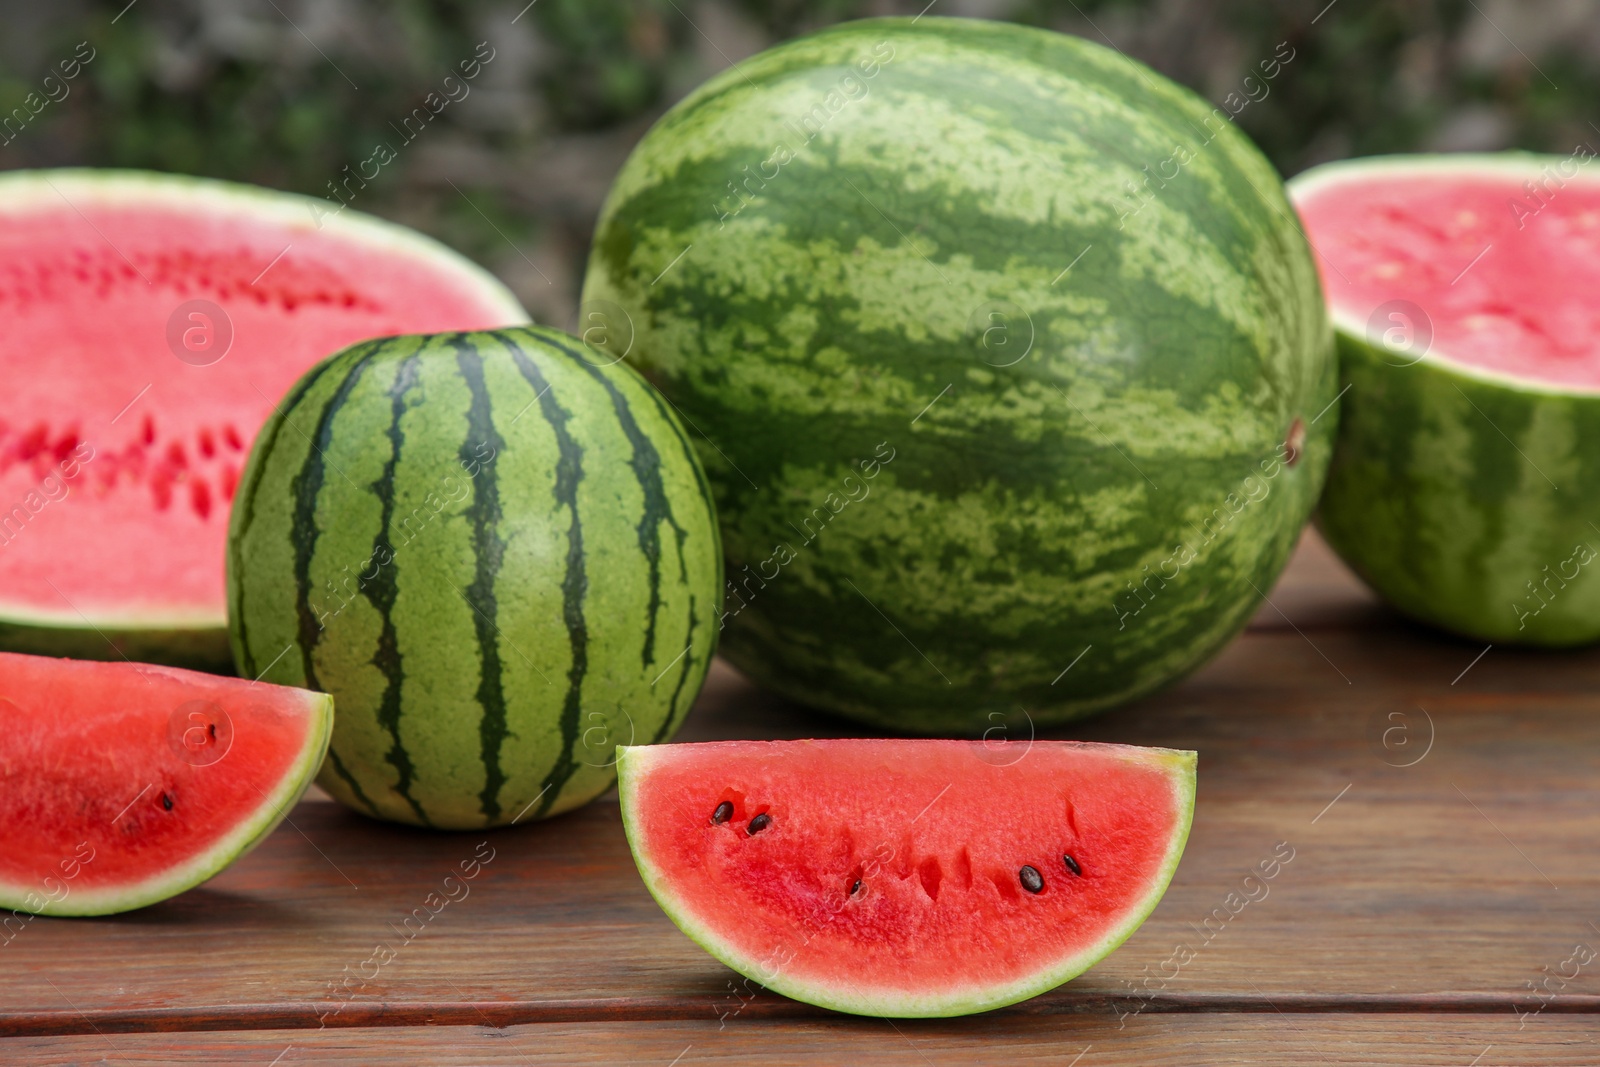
0,531 -> 1600,1033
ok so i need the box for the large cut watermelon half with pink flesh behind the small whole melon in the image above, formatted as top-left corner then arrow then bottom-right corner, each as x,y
0,171 -> 526,664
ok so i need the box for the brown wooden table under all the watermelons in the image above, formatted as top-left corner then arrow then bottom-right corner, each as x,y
0,534 -> 1600,1067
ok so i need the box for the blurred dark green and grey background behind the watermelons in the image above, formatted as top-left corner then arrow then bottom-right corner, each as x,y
0,0 -> 1600,328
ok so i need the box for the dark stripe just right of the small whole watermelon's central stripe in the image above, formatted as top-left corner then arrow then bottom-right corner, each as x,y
501,334 -> 589,817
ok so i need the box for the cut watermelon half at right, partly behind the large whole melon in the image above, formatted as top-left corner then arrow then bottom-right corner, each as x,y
1293,154 -> 1600,645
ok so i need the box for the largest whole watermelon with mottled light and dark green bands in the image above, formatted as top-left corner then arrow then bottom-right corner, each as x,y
582,18 -> 1336,736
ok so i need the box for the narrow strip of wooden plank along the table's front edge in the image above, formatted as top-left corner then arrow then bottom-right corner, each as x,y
0,1013 -> 1600,1067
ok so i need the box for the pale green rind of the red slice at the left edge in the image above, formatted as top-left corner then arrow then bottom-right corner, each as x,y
0,681 -> 333,917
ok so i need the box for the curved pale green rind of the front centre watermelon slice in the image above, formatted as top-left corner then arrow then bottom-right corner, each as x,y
616,745 -> 1197,1019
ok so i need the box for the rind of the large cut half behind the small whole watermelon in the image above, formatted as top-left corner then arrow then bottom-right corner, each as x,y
0,168 -> 530,670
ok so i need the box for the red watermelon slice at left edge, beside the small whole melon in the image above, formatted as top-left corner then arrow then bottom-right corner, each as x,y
0,653 -> 333,915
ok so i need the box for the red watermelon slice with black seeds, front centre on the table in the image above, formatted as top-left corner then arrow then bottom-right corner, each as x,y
618,741 -> 1195,1017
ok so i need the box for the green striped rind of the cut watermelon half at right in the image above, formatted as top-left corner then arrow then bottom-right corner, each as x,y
1288,152 -> 1600,648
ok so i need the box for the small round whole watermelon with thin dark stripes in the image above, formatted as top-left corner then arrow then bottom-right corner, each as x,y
227,326 -> 722,827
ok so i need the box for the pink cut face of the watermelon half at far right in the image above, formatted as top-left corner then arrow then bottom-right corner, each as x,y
1294,154 -> 1600,389
